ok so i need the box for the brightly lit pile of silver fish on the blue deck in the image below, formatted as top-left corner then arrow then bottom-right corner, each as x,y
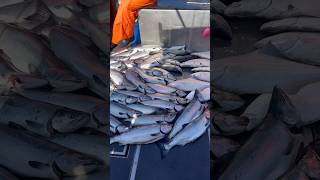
110,46 -> 210,155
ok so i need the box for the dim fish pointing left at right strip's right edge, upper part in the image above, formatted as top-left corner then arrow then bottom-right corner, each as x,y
255,32 -> 320,66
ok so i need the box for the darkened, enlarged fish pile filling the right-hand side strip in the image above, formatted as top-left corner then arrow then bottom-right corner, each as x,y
211,0 -> 320,180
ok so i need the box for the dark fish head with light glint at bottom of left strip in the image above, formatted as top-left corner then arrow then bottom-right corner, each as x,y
52,150 -> 102,176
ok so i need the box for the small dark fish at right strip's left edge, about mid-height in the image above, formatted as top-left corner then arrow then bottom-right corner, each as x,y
212,89 -> 245,111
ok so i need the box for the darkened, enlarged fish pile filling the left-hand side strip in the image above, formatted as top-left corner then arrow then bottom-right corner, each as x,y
0,0 -> 110,180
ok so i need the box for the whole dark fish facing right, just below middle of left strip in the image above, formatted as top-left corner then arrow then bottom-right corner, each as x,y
0,96 -> 90,136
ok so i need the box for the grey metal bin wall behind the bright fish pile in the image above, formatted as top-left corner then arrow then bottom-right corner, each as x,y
139,9 -> 210,51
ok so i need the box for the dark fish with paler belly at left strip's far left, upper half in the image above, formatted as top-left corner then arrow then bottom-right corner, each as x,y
0,23 -> 86,91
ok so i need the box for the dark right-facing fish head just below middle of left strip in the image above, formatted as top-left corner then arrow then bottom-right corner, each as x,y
52,110 -> 90,132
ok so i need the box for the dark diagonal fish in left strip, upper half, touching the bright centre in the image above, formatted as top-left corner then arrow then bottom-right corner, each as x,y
49,27 -> 109,98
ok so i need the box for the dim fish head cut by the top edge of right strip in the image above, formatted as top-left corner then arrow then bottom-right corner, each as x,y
224,0 -> 272,17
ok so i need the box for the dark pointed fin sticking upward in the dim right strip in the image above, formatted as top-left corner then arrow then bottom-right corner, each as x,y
269,86 -> 301,126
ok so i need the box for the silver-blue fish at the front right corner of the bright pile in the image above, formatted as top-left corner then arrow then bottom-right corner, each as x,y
164,110 -> 210,152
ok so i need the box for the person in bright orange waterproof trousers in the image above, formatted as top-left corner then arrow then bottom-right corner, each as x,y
112,0 -> 156,48
